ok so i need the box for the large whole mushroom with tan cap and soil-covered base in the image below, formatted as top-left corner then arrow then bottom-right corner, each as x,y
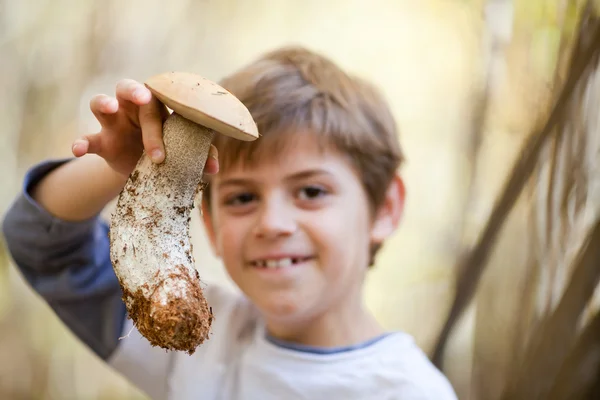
109,72 -> 258,355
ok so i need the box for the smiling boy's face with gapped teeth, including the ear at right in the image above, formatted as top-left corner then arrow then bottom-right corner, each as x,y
204,135 -> 403,323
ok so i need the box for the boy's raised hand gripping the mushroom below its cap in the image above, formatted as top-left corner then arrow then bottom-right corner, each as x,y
72,79 -> 219,176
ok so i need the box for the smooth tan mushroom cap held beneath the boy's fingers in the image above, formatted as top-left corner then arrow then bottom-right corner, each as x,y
145,72 -> 258,141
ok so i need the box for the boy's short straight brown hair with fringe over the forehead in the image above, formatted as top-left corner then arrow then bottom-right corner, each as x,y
202,46 -> 403,266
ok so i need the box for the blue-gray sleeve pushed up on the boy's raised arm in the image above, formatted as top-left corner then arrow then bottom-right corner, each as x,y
2,160 -> 126,360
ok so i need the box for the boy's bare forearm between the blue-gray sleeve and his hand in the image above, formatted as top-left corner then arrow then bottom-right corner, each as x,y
31,155 -> 127,221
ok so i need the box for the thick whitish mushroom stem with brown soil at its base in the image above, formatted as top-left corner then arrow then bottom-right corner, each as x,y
110,113 -> 214,354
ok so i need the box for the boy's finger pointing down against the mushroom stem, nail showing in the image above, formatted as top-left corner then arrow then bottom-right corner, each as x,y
139,98 -> 165,164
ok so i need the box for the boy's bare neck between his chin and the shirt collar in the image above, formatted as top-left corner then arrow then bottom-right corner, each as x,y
267,306 -> 385,348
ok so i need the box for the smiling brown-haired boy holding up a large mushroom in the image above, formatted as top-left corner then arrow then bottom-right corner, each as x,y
4,48 -> 456,400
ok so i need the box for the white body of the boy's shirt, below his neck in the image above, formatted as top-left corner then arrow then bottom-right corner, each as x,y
108,286 -> 456,400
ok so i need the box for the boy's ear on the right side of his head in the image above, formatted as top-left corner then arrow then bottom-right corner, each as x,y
371,174 -> 406,244
